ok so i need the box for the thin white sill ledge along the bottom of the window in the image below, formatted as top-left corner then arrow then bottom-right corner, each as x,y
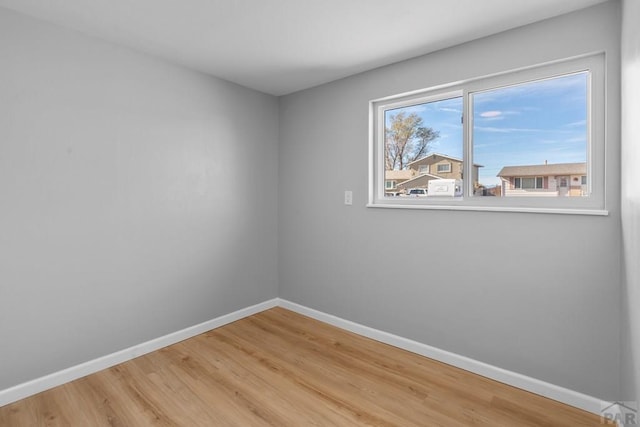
366,203 -> 609,216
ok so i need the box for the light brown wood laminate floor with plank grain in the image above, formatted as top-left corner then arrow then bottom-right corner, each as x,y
0,308 -> 602,427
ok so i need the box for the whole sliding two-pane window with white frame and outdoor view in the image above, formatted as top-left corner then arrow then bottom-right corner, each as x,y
368,54 -> 606,214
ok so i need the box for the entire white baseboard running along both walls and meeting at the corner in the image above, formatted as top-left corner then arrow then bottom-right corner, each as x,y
0,298 -> 611,415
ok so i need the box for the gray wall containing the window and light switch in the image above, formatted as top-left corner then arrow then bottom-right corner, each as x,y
279,2 -> 621,399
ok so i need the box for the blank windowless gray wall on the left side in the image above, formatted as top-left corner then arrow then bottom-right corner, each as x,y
0,9 -> 278,389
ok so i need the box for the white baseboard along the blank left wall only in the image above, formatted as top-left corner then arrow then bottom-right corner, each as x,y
0,298 -> 279,406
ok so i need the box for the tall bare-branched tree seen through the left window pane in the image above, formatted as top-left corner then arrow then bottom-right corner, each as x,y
384,111 -> 440,170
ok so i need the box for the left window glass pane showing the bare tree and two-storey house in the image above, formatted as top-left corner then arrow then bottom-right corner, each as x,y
384,97 -> 463,196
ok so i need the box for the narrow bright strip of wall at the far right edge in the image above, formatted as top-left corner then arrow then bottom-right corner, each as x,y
621,0 -> 640,410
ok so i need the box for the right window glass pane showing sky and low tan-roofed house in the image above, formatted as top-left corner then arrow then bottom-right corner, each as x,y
471,72 -> 588,196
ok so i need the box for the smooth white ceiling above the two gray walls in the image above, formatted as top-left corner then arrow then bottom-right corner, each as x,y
0,0 -> 605,95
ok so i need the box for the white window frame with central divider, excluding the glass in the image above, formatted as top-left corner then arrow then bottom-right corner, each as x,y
367,53 -> 608,215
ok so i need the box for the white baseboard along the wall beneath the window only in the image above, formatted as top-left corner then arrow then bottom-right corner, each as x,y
278,298 -> 611,415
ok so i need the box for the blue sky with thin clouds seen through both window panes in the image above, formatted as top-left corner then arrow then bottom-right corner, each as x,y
393,73 -> 588,185
